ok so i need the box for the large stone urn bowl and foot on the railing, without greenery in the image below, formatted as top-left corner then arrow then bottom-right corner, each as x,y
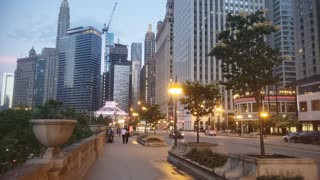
30,119 -> 78,158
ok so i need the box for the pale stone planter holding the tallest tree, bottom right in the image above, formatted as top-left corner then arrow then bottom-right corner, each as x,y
214,154 -> 320,180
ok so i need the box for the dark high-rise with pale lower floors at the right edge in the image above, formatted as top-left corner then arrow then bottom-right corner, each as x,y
294,0 -> 320,131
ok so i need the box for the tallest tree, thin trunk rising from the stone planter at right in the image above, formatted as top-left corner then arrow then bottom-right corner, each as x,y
209,11 -> 281,157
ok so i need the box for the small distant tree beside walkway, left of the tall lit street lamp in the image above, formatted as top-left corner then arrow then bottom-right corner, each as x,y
141,104 -> 166,131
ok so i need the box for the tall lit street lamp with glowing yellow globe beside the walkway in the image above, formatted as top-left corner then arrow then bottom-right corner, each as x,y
169,76 -> 182,147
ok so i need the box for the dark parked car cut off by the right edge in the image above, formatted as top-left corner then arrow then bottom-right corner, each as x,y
290,131 -> 320,144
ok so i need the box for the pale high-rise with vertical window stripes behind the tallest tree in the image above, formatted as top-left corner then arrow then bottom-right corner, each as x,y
173,0 -> 265,129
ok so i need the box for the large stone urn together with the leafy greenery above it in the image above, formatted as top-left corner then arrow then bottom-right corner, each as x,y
30,100 -> 77,158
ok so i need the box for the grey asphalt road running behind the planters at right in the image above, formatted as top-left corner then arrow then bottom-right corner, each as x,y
164,132 -> 320,160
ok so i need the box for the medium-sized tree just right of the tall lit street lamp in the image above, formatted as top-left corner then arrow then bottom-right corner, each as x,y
180,81 -> 221,143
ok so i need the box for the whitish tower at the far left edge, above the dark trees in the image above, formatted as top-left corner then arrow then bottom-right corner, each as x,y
0,73 -> 14,110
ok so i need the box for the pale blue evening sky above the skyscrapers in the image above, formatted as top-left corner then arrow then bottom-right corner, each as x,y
0,0 -> 167,72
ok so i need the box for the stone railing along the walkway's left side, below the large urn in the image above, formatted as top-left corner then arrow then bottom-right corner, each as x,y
0,132 -> 105,180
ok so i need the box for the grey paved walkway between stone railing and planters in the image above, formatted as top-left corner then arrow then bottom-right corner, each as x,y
85,136 -> 193,180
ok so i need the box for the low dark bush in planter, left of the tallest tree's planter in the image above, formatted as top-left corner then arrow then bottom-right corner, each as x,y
185,149 -> 228,168
